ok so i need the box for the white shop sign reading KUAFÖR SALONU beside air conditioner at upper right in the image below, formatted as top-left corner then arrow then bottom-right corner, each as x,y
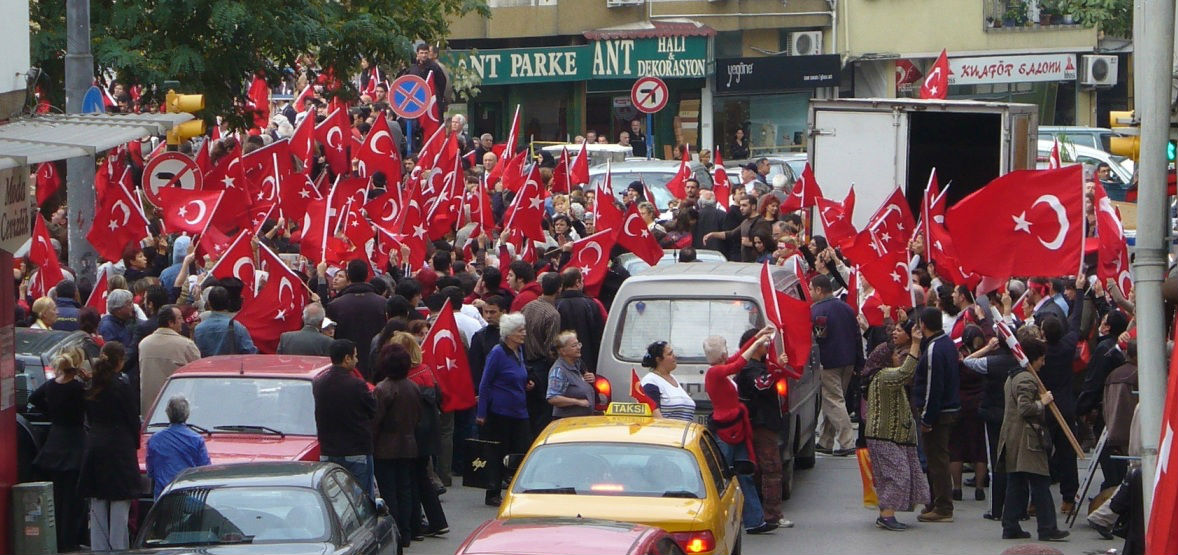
949,54 -> 1076,85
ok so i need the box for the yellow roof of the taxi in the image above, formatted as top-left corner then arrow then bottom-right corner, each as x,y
537,416 -> 704,448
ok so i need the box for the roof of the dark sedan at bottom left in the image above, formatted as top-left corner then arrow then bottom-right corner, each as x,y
168,461 -> 333,490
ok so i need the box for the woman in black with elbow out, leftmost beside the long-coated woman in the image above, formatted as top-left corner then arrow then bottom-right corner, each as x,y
28,346 -> 86,551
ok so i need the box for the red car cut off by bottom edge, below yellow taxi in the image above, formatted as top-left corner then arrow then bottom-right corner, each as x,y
455,518 -> 683,555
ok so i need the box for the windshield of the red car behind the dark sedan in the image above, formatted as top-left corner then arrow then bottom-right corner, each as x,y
147,376 -> 316,436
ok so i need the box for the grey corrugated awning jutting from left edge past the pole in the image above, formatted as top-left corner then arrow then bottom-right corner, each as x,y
0,113 -> 192,170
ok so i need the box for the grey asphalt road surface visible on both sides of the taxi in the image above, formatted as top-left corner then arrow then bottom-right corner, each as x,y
406,455 -> 1123,555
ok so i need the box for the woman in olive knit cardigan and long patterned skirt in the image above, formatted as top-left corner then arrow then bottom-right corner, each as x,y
863,321 -> 929,531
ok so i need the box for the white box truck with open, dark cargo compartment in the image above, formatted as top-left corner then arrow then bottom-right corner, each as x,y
808,98 -> 1039,229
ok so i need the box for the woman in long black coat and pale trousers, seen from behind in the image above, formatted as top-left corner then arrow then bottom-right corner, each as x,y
78,342 -> 143,551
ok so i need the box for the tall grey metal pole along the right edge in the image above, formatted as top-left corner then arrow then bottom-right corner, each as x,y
1133,0 -> 1174,522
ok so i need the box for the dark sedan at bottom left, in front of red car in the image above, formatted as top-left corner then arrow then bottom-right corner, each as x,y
131,462 -> 401,555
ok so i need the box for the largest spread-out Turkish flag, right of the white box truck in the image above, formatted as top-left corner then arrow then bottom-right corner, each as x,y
945,164 -> 1084,279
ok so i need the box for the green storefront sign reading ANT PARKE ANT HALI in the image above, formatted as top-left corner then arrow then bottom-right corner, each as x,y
450,37 -> 708,85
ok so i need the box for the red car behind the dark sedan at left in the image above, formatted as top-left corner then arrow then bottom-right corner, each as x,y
139,355 -> 331,485
